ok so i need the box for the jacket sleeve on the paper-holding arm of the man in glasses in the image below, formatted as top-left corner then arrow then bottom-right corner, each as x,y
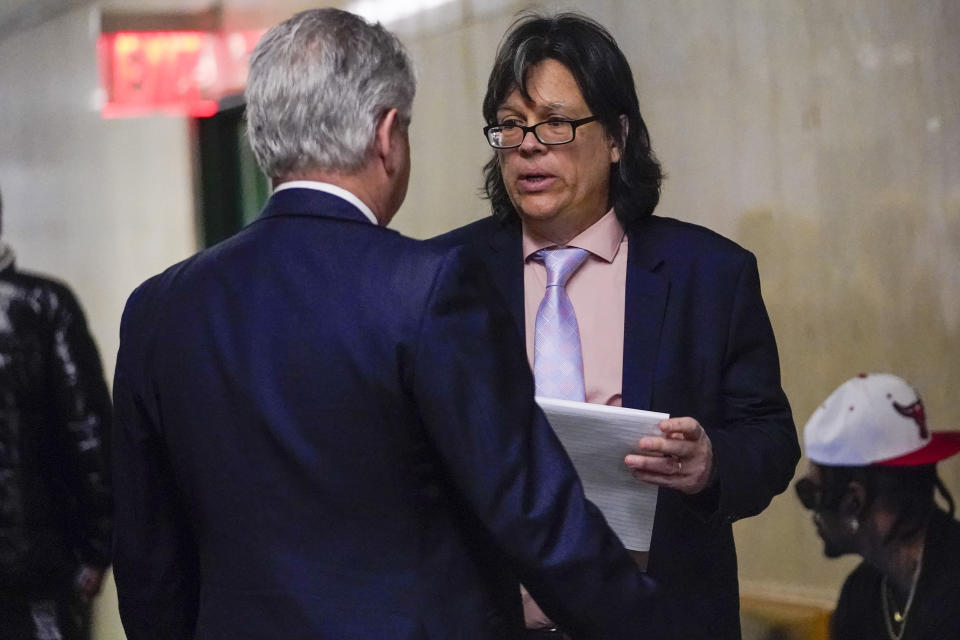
700,255 -> 800,522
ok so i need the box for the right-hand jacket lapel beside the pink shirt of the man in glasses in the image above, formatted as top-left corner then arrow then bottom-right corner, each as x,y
623,224 -> 670,409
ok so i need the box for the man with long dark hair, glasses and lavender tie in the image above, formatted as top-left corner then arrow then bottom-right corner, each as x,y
435,13 -> 799,640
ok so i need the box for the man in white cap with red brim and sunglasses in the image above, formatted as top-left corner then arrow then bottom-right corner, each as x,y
796,374 -> 960,640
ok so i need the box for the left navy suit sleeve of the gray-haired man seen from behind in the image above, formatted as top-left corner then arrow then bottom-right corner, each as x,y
112,292 -> 199,640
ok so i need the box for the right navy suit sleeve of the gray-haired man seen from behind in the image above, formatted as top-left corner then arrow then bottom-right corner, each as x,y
412,246 -> 658,638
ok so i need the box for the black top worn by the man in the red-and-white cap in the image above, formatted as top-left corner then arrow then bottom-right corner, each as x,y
830,509 -> 960,640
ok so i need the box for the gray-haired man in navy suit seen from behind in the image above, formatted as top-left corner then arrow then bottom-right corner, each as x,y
113,9 -> 657,640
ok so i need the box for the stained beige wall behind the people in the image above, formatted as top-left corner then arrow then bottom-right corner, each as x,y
0,0 -> 960,638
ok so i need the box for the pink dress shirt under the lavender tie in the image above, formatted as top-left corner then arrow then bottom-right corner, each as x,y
523,209 -> 627,407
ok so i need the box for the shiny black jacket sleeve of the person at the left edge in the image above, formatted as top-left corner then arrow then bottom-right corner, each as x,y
50,289 -> 113,567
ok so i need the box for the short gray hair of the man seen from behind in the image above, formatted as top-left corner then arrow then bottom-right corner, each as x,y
246,9 -> 416,178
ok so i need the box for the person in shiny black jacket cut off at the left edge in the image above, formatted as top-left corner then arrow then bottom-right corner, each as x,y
0,182 -> 112,640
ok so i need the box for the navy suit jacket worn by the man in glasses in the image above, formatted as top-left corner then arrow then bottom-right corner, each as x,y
432,216 -> 800,640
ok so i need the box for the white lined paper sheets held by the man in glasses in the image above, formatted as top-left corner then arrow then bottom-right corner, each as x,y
537,398 -> 669,551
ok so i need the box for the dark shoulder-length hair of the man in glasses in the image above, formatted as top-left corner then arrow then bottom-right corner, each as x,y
483,13 -> 663,228
